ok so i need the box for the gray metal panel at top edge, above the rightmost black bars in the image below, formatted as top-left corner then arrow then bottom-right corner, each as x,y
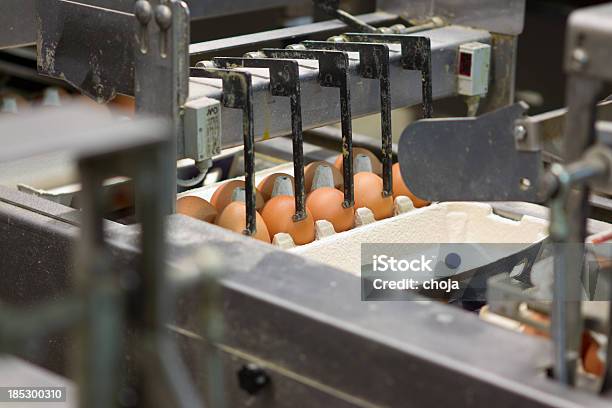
378,0 -> 525,35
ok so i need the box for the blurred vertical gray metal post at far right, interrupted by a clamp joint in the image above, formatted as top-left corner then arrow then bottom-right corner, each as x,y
551,75 -> 601,385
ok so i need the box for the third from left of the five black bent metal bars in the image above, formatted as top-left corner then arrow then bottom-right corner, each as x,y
261,48 -> 355,208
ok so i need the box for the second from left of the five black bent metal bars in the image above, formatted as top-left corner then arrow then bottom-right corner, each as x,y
213,57 -> 306,222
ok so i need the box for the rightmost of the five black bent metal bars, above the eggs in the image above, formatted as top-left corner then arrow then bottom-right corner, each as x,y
343,33 -> 433,118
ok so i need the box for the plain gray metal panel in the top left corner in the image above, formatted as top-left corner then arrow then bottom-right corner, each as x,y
0,0 -> 36,49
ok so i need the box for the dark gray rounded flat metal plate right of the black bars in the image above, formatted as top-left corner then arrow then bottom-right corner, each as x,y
398,103 -> 542,202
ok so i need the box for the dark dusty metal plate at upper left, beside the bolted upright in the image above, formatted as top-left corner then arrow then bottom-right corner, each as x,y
36,0 -> 135,102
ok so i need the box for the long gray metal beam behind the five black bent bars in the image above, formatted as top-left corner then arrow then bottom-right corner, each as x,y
189,26 -> 491,148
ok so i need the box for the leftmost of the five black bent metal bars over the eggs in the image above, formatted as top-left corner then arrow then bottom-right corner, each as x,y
190,67 -> 257,236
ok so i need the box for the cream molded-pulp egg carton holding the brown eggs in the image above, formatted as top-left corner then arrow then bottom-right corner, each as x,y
179,163 -> 548,276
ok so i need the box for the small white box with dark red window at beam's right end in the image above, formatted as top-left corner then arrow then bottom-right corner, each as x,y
457,42 -> 491,96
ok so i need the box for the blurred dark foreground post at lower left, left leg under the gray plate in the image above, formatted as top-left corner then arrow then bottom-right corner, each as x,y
75,160 -> 123,408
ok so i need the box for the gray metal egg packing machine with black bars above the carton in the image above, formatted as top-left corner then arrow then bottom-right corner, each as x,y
0,0 -> 611,407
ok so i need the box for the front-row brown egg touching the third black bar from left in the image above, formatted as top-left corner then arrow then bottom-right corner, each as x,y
306,187 -> 355,232
